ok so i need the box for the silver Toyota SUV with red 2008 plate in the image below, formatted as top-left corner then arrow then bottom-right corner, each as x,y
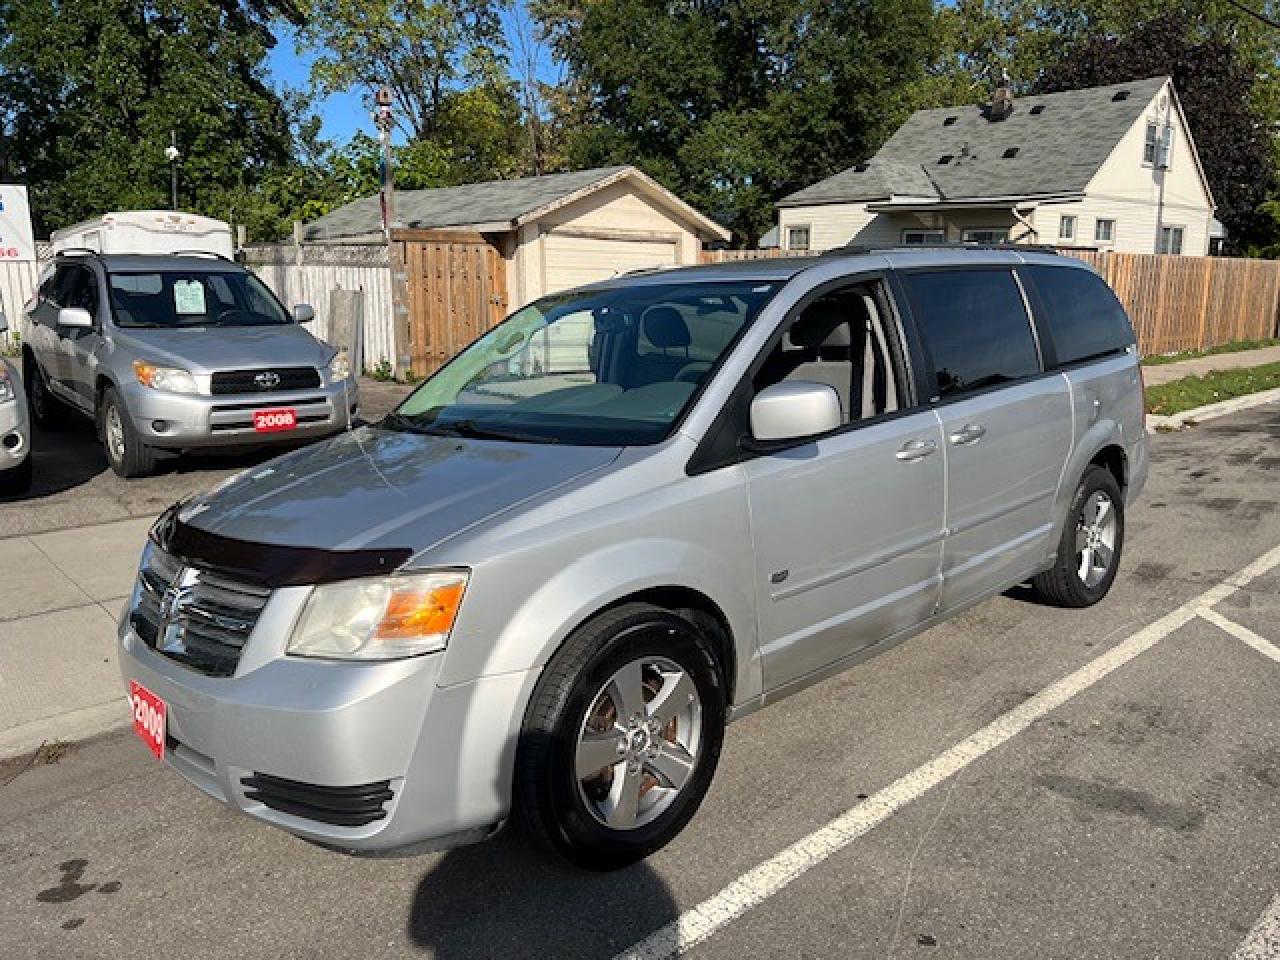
22,252 -> 357,476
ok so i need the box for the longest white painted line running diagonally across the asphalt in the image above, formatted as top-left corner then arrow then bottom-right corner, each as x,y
616,547 -> 1280,960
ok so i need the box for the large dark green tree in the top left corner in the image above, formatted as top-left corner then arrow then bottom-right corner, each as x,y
0,0 -> 297,232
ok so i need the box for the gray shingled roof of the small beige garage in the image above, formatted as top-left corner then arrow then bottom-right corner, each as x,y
302,166 -> 627,241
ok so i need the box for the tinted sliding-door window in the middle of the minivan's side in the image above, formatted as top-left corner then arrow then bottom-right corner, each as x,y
902,270 -> 1041,398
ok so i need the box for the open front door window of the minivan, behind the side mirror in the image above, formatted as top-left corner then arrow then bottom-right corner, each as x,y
754,284 -> 902,424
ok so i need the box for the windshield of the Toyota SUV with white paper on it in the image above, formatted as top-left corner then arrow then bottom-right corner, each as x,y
110,270 -> 293,326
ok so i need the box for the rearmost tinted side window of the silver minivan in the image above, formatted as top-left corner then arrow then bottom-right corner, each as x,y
1025,266 -> 1134,364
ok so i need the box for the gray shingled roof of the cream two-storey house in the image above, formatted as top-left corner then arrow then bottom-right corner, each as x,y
778,77 -> 1167,206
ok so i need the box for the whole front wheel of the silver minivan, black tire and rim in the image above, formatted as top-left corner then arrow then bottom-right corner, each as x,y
515,603 -> 726,870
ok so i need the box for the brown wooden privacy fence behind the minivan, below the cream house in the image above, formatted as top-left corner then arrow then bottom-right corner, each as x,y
703,247 -> 1280,356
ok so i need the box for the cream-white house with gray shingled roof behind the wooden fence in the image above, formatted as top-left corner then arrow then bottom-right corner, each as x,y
778,77 -> 1213,256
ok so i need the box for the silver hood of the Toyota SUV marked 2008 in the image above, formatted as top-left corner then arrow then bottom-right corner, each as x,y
113,324 -> 333,374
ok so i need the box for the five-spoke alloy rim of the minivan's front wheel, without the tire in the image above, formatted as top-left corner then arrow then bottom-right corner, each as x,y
573,657 -> 703,829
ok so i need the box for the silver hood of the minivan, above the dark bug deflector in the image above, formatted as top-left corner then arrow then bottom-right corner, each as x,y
180,426 -> 622,553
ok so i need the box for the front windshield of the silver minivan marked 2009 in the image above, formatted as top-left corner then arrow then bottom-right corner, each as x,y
381,282 -> 781,445
